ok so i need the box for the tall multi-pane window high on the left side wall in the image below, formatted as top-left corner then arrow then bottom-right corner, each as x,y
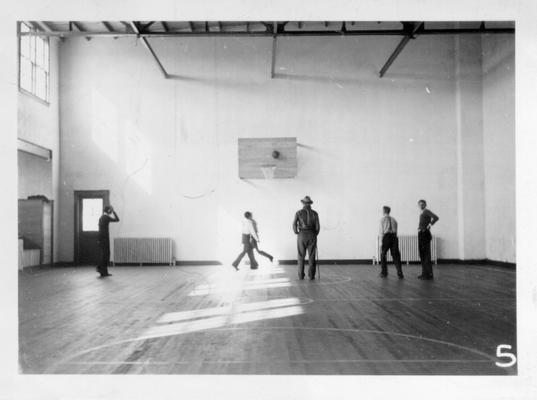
19,22 -> 50,103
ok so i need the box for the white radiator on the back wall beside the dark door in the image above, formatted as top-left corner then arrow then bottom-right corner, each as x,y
113,238 -> 174,265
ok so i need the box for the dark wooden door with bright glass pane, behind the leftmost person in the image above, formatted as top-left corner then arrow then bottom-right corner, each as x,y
75,190 -> 109,265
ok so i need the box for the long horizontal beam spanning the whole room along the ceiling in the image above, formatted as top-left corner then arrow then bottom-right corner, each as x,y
20,24 -> 515,37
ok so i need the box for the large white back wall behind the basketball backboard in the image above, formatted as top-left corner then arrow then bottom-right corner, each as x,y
55,32 -> 510,261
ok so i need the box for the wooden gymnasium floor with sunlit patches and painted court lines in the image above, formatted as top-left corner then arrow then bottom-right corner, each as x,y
19,265 -> 516,375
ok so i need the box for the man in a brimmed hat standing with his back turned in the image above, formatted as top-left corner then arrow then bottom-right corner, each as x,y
293,196 -> 321,280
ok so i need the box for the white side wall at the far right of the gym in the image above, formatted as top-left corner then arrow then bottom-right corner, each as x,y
483,35 -> 516,263
